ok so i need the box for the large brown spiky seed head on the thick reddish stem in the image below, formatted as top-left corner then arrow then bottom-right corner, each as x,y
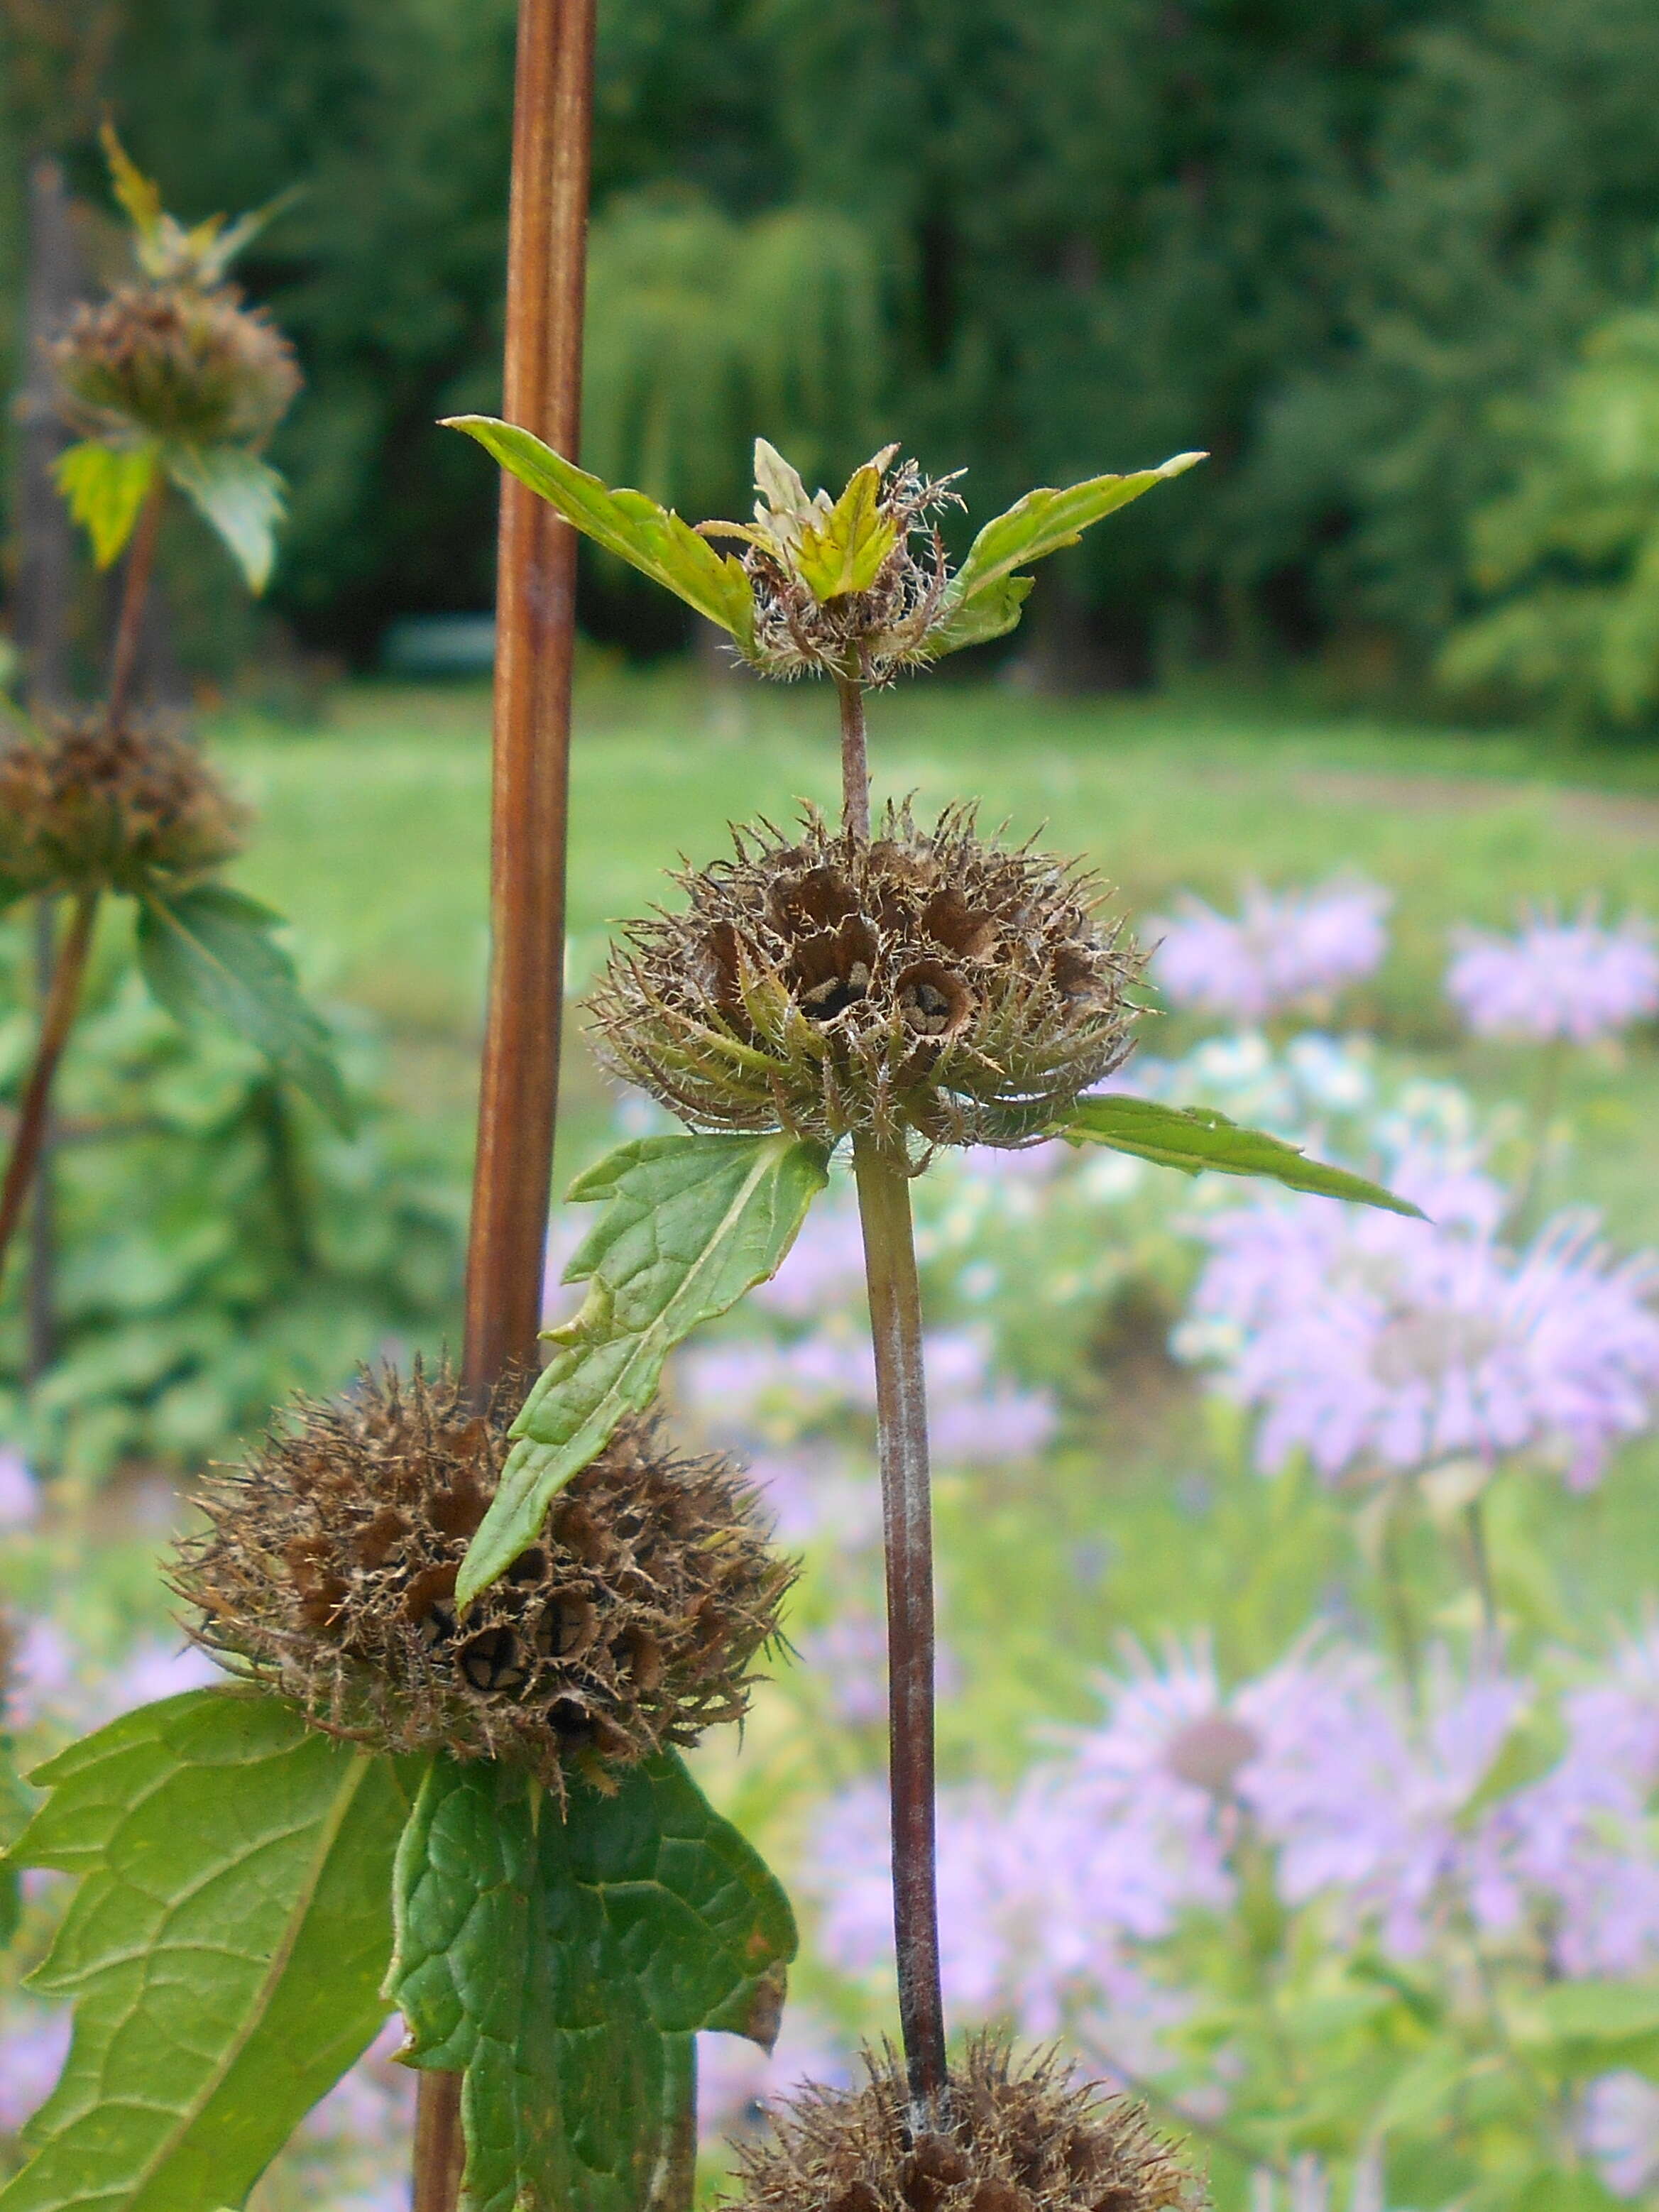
173,1365 -> 794,1787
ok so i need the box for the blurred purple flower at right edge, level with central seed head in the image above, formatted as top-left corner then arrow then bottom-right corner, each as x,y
1447,902 -> 1659,1044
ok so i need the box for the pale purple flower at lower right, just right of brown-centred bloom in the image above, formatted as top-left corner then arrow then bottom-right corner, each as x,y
1237,1648 -> 1526,1958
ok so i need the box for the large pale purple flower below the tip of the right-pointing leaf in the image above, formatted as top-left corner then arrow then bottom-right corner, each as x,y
1177,1161 -> 1659,1489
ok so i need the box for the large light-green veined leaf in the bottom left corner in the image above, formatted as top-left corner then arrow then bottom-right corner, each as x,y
0,1690 -> 407,2212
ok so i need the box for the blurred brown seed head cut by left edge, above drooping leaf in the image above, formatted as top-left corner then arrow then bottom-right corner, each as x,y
0,717 -> 246,894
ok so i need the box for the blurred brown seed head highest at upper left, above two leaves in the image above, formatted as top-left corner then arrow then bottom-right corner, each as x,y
49,283 -> 301,447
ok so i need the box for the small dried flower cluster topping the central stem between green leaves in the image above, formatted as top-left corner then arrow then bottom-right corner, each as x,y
701,438 -> 962,684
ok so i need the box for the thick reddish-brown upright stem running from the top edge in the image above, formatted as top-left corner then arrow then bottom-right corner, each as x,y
412,0 -> 595,2212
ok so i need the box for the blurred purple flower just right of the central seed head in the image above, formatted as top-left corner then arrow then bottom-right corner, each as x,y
1152,878 -> 1394,1022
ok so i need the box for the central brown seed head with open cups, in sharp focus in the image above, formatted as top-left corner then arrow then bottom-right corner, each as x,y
591,807 -> 1141,1146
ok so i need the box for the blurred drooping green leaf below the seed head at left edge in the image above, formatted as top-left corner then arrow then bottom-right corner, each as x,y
137,882 -> 351,1135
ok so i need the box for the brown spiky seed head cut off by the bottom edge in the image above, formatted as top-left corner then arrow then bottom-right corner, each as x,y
737,2037 -> 1205,2212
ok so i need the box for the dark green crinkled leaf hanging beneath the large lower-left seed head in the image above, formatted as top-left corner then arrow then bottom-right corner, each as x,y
387,1752 -> 796,2212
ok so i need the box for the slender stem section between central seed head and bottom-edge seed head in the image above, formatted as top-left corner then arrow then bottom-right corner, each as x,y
852,1135 -> 947,2128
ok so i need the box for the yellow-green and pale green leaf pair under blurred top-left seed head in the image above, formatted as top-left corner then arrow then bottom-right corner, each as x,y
53,438 -> 283,593
